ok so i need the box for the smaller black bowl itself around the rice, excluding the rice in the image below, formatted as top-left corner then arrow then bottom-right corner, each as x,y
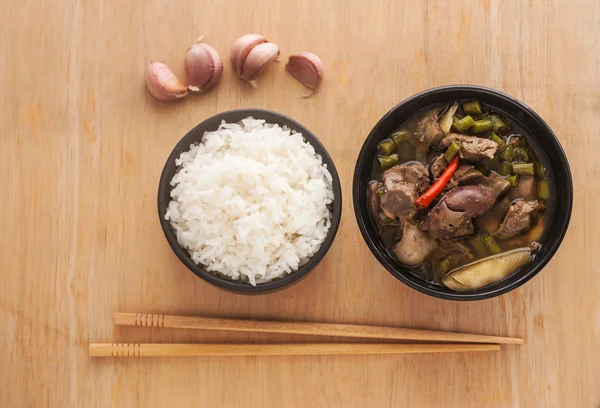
158,109 -> 342,294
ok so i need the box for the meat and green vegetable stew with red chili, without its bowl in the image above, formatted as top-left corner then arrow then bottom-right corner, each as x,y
367,100 -> 555,291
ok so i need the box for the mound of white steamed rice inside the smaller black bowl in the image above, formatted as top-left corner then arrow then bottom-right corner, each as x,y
165,117 -> 333,285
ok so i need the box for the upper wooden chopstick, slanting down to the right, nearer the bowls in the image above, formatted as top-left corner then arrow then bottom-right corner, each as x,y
115,313 -> 523,344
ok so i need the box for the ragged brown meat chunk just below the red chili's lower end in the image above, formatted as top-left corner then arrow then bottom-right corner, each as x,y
421,199 -> 473,239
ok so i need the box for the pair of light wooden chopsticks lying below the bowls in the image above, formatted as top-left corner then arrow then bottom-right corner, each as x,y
89,313 -> 523,357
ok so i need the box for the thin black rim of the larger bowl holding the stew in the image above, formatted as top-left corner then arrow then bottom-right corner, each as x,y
352,84 -> 573,301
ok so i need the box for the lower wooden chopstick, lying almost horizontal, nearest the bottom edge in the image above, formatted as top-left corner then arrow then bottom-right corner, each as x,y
89,343 -> 500,357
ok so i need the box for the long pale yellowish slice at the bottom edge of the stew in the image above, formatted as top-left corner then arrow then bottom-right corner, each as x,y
442,247 -> 531,292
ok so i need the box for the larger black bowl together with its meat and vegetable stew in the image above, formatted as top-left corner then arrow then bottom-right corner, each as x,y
353,85 -> 573,300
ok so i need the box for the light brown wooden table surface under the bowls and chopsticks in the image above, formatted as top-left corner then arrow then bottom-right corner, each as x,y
0,0 -> 600,407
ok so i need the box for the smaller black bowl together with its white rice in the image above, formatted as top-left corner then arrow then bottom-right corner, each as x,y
158,109 -> 342,293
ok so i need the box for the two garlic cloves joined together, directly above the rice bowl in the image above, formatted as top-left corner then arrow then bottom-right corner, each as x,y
229,34 -> 279,88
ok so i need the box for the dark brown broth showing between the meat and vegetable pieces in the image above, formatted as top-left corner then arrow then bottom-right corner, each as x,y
371,101 -> 556,286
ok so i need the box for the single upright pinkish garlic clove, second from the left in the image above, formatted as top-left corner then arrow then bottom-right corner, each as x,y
185,42 -> 223,92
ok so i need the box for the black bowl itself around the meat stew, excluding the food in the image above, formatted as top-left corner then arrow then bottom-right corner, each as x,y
352,85 -> 573,300
